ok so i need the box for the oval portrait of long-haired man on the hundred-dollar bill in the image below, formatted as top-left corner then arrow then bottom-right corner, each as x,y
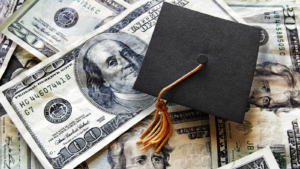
75,33 -> 156,114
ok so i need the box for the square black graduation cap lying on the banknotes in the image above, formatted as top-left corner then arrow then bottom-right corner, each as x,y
133,2 -> 261,123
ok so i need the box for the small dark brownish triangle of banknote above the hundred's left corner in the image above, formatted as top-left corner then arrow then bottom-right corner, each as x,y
0,45 -> 41,86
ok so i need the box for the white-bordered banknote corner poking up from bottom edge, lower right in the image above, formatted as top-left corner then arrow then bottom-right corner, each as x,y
219,147 -> 279,169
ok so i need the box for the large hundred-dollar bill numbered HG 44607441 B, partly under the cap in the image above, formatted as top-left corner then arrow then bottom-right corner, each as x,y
0,0 -> 245,168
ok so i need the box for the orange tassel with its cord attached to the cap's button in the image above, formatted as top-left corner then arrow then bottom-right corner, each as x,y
136,64 -> 203,152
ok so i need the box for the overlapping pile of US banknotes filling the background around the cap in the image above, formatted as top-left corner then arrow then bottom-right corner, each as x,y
0,0 -> 300,169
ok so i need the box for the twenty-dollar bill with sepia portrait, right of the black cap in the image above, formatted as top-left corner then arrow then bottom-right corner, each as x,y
227,1 -> 300,112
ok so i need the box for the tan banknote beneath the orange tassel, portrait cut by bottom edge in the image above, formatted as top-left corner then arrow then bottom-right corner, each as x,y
82,106 -> 211,169
